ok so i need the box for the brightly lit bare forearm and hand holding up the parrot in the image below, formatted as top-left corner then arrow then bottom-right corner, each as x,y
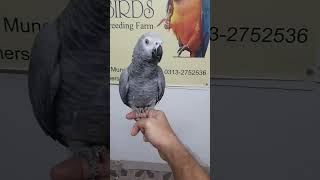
126,110 -> 209,180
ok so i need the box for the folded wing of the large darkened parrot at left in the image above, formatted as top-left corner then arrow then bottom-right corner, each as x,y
28,23 -> 64,144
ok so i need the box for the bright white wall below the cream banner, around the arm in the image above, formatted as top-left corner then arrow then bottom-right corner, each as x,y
110,85 -> 210,165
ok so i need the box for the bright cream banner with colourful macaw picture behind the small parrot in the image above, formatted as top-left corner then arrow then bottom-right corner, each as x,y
110,0 -> 210,87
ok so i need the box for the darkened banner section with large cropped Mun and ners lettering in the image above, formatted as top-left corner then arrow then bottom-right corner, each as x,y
0,0 -> 68,71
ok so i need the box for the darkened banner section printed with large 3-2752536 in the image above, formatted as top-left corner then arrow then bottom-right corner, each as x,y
210,0 -> 320,80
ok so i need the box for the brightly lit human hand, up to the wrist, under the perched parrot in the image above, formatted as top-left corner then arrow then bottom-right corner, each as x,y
126,110 -> 180,160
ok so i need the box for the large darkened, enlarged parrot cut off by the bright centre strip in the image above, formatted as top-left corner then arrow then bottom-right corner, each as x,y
28,0 -> 109,177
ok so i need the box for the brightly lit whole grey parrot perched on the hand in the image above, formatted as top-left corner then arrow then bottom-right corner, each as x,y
119,32 -> 165,114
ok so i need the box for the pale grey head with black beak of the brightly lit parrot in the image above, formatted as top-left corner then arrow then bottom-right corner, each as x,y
133,32 -> 163,64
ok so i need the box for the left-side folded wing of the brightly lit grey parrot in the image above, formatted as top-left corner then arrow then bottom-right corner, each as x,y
119,69 -> 130,107
